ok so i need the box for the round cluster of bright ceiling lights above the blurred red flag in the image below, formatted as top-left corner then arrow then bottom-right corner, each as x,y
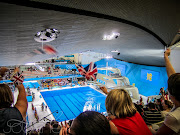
34,29 -> 60,42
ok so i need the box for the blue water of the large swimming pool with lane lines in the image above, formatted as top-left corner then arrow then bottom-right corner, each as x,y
41,87 -> 106,122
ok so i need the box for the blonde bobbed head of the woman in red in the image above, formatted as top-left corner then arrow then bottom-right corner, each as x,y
105,89 -> 136,118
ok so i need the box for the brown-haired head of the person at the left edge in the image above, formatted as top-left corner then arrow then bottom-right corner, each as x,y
0,84 -> 14,109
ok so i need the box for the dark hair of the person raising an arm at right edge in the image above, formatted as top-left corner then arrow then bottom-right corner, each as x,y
168,73 -> 180,101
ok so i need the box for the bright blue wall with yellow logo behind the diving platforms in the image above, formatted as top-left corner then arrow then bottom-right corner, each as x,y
96,59 -> 168,96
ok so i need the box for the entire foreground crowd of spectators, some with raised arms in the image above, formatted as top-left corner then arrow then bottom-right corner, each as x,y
0,49 -> 180,135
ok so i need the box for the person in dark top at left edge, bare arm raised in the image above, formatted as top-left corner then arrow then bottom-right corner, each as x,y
0,68 -> 28,135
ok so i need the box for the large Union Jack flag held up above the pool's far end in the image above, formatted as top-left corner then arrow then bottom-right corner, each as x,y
75,62 -> 97,80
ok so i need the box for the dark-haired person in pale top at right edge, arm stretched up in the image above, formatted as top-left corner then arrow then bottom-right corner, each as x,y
150,49 -> 180,135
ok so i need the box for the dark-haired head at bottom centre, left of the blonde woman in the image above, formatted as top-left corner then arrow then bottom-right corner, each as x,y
70,111 -> 111,135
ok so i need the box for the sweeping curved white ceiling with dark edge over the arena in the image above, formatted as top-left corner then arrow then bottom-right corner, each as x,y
0,0 -> 180,66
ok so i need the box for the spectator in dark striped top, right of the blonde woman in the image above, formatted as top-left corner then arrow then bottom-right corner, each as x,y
143,103 -> 163,125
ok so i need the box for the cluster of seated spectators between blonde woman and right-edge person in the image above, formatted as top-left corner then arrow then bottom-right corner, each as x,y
134,88 -> 173,125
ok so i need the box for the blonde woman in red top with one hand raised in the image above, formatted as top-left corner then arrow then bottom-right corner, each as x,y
100,87 -> 152,135
